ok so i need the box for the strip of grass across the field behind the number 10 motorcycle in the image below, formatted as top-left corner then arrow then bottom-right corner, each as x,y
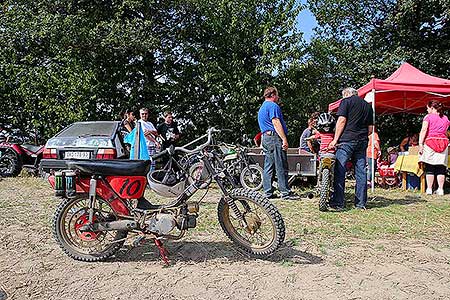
0,178 -> 450,254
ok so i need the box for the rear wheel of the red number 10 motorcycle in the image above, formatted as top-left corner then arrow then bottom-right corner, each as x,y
53,195 -> 128,262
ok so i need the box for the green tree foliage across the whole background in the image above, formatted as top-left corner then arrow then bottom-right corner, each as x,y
0,0 -> 450,146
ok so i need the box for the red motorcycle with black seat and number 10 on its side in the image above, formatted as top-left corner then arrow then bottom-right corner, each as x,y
48,128 -> 285,264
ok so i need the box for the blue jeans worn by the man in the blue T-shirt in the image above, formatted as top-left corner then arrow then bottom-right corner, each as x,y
261,133 -> 291,197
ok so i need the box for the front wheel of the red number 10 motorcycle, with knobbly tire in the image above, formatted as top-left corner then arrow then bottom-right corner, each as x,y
217,189 -> 285,258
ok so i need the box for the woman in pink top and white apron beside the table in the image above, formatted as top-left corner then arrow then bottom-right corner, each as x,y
419,100 -> 450,196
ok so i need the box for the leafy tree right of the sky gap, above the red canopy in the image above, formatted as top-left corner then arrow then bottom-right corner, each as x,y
302,0 -> 450,144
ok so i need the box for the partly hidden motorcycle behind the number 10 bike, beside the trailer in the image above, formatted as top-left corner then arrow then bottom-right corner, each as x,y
220,144 -> 263,191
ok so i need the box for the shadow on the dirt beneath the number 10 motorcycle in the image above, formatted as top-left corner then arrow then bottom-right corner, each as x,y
113,240 -> 323,265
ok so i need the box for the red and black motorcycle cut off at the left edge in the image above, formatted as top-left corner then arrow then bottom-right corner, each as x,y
0,129 -> 44,177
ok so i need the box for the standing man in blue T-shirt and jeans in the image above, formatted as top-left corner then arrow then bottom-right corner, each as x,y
258,87 -> 299,200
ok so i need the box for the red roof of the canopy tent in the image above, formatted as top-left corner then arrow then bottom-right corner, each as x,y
328,63 -> 450,115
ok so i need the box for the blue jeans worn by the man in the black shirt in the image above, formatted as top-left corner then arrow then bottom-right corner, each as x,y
330,140 -> 367,208
